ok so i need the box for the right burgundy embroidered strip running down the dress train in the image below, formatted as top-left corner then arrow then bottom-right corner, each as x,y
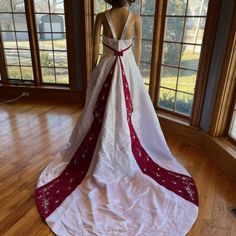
119,55 -> 198,206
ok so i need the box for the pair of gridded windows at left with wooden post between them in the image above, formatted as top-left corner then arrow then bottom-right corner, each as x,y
0,0 -> 69,85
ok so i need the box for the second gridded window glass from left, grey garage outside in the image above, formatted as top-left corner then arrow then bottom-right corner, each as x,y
34,0 -> 69,84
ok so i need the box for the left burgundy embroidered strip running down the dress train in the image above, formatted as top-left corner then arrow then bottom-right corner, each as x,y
35,58 -> 117,220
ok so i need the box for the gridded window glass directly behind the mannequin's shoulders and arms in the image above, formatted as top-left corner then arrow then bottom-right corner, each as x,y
94,0 -> 156,89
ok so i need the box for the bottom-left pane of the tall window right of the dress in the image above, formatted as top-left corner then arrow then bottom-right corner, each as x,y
158,88 -> 175,111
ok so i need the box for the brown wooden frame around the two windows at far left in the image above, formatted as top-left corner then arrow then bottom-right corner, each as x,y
0,0 -> 76,89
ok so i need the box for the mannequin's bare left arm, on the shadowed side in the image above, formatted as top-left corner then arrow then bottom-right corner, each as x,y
92,13 -> 102,69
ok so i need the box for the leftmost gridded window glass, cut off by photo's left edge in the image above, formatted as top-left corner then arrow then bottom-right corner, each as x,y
0,0 -> 34,83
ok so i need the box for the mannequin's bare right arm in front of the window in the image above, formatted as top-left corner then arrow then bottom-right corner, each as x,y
134,15 -> 142,66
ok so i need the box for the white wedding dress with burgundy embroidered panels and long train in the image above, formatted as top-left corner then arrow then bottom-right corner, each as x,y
35,11 -> 198,236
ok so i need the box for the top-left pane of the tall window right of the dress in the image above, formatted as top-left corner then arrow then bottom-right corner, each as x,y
166,0 -> 187,16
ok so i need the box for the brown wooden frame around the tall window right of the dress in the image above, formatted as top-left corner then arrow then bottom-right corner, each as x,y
149,0 -> 220,127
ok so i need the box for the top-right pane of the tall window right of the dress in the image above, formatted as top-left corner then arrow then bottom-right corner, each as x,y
187,0 -> 208,16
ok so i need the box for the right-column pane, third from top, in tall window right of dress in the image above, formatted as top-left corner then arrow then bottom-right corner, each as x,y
180,44 -> 201,70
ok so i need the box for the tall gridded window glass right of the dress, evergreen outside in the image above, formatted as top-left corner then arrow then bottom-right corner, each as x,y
157,0 -> 208,118
